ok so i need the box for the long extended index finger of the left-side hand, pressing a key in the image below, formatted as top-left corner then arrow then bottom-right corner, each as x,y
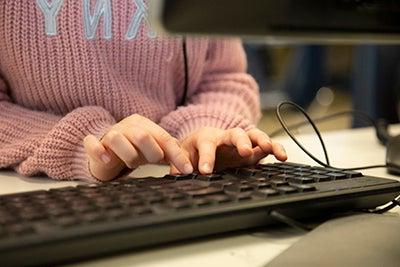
138,120 -> 193,174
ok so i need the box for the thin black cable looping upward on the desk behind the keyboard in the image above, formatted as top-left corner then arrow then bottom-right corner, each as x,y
276,101 -> 387,171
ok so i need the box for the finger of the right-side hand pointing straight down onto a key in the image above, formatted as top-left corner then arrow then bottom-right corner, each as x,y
197,139 -> 217,174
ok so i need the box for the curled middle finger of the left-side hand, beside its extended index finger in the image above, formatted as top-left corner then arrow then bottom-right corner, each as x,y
124,128 -> 164,163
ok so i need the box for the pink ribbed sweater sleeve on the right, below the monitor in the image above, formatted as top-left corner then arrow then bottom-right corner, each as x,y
160,40 -> 260,139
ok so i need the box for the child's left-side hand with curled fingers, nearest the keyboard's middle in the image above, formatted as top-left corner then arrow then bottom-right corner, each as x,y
84,115 -> 193,181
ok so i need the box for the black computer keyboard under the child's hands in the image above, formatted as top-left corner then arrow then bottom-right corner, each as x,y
0,163 -> 400,266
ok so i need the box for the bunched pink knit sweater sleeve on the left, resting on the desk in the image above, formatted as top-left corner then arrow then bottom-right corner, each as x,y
0,79 -> 115,181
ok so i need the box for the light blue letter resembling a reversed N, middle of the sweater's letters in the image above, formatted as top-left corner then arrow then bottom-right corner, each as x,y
83,0 -> 112,40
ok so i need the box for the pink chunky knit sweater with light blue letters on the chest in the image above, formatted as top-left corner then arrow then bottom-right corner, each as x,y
0,0 -> 259,180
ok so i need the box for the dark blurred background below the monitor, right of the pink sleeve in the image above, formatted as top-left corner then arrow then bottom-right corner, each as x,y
245,43 -> 400,136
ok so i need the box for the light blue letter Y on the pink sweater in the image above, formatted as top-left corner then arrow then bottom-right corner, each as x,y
36,0 -> 64,36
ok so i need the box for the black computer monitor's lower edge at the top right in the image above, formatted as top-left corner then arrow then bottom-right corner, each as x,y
149,0 -> 400,43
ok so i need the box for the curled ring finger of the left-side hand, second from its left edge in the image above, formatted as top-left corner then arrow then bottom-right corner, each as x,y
102,130 -> 141,169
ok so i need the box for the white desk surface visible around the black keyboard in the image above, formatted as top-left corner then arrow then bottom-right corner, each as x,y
0,126 -> 400,267
